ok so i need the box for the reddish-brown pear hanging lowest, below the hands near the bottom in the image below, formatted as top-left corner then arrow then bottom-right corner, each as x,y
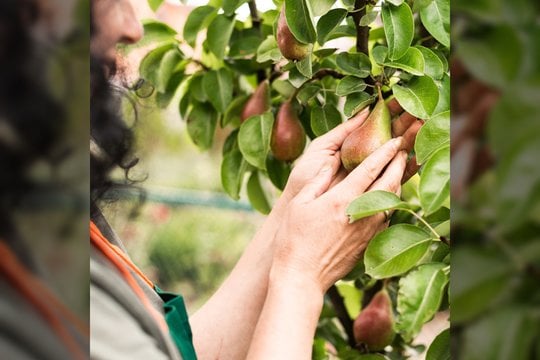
353,288 -> 396,351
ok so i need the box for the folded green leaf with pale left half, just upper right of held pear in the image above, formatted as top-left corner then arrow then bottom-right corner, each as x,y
392,76 -> 439,119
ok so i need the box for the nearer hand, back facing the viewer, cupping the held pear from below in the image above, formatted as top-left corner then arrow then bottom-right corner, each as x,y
271,137 -> 407,295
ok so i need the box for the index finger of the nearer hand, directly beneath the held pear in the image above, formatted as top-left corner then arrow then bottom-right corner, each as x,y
328,137 -> 403,201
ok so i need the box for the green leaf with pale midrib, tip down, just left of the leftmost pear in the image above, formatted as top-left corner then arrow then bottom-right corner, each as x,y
203,68 -> 233,114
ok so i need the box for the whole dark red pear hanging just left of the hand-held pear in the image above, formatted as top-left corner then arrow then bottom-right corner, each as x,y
270,101 -> 306,162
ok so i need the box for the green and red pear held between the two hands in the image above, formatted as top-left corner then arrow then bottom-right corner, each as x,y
341,90 -> 392,171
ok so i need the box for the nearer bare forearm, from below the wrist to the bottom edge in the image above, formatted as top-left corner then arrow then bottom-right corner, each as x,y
247,266 -> 324,360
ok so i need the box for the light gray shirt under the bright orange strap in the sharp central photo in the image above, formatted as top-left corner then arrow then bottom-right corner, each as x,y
90,212 -> 181,360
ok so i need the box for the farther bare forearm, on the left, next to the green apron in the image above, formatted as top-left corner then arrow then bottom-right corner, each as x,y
190,199 -> 285,360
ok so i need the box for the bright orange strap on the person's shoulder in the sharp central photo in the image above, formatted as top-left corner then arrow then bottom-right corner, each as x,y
90,221 -> 168,331
